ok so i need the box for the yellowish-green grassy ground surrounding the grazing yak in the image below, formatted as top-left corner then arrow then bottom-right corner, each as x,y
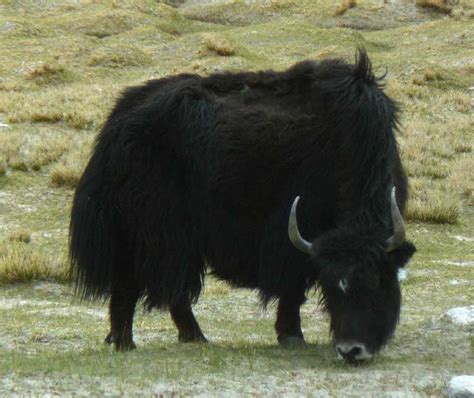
0,0 -> 474,396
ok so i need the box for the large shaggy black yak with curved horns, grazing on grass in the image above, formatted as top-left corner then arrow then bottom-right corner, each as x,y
70,49 -> 416,361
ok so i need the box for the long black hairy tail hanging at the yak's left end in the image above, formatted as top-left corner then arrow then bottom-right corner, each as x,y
69,151 -> 125,299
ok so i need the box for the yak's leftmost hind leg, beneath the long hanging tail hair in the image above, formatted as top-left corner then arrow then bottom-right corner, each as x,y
105,286 -> 139,351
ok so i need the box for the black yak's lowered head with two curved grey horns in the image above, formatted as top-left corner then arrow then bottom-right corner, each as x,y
288,190 -> 416,361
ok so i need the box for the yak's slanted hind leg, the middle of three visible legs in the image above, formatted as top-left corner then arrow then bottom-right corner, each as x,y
170,298 -> 207,343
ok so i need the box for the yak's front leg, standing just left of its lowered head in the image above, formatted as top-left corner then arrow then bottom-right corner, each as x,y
275,295 -> 305,345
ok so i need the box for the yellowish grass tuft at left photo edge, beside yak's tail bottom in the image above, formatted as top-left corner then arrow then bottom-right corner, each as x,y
0,242 -> 69,285
